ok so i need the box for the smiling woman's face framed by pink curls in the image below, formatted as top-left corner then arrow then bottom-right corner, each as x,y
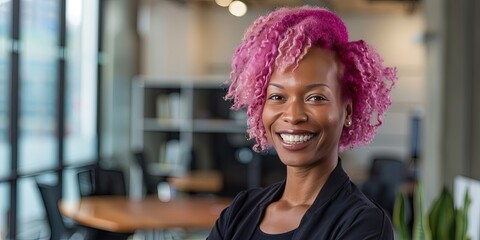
262,47 -> 352,167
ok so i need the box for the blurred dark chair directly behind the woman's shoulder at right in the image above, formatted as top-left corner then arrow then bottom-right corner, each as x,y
361,156 -> 406,216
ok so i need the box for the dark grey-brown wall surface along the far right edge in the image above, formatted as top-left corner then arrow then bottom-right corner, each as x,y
442,0 -> 480,184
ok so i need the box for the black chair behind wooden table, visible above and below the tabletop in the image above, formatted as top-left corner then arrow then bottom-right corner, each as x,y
77,166 -> 134,240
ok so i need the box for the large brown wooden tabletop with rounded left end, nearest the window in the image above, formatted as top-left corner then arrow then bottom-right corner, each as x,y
59,196 -> 231,232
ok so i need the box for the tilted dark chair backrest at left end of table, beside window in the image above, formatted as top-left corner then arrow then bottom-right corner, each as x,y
37,181 -> 68,240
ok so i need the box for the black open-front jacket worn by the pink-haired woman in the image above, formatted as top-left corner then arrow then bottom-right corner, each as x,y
207,160 -> 394,240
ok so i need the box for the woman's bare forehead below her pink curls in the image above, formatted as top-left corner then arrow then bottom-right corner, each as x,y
270,47 -> 342,85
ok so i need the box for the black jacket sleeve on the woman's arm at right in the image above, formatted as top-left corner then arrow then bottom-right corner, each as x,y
337,208 -> 394,240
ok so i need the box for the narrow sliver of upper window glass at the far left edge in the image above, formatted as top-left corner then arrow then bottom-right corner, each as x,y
0,1 -> 12,178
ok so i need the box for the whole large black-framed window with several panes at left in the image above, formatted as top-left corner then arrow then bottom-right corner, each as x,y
0,0 -> 100,236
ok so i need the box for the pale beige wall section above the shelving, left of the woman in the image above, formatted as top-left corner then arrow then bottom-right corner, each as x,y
139,1 -> 192,76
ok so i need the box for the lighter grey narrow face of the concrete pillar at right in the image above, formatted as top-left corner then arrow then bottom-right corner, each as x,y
421,0 -> 445,206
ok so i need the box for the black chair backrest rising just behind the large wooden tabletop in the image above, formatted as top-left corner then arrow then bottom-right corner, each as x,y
77,168 -> 127,197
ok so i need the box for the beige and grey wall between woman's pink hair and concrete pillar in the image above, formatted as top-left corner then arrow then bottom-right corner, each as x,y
341,12 -> 426,180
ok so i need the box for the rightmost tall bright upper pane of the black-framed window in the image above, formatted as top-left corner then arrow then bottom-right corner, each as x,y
65,0 -> 98,164
